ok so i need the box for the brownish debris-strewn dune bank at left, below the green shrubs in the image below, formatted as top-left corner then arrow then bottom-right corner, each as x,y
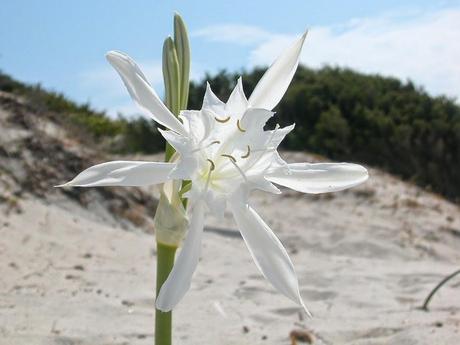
0,92 -> 156,228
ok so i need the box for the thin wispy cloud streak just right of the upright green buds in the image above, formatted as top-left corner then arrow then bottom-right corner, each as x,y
192,24 -> 271,45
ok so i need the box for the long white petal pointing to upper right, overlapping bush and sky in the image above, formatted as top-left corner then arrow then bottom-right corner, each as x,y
249,32 -> 307,110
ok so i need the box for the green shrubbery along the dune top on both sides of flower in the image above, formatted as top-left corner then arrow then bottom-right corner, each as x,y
0,66 -> 460,202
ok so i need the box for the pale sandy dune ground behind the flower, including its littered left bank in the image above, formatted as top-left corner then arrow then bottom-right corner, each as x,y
0,86 -> 460,345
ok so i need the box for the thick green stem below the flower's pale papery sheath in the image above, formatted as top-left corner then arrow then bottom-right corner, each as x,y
155,242 -> 177,345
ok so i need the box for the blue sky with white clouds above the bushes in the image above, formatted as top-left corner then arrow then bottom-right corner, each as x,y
0,0 -> 460,115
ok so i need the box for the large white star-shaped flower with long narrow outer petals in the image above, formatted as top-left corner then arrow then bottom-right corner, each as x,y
59,34 -> 368,312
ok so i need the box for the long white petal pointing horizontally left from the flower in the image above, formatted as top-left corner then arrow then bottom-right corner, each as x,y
57,161 -> 176,187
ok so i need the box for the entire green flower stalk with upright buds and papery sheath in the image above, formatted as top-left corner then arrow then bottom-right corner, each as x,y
154,13 -> 190,345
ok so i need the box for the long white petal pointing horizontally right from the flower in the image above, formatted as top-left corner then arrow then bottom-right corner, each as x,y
266,163 -> 369,194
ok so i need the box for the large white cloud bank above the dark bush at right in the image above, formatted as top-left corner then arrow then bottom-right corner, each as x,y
250,9 -> 460,99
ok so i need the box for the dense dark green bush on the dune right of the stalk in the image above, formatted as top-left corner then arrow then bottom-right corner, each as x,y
190,67 -> 460,199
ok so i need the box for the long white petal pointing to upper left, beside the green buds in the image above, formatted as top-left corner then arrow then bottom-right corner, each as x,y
106,51 -> 186,135
